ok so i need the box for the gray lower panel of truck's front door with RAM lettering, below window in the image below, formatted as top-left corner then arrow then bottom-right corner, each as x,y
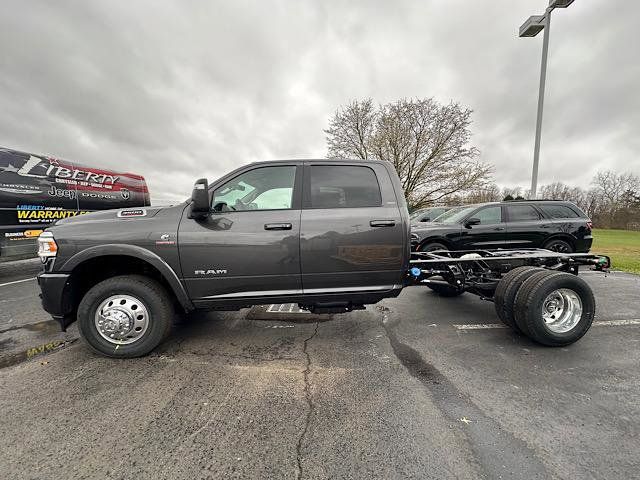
178,210 -> 302,299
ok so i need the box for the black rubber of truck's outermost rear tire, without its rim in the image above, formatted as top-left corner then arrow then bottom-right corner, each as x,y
515,272 -> 596,347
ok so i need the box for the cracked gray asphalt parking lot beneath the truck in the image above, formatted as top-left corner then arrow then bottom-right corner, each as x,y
0,261 -> 640,479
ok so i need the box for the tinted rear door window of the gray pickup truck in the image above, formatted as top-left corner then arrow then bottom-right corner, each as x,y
305,165 -> 382,208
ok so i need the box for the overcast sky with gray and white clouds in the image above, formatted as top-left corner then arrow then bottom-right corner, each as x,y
0,0 -> 640,203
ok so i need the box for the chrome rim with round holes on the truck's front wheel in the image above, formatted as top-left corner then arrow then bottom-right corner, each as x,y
94,295 -> 149,345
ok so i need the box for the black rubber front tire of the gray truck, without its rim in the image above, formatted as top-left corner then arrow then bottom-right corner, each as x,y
78,275 -> 174,358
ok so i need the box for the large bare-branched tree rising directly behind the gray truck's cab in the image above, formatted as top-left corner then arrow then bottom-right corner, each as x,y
325,98 -> 492,208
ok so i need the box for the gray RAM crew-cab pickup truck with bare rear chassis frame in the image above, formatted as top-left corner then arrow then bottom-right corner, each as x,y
38,160 -> 608,357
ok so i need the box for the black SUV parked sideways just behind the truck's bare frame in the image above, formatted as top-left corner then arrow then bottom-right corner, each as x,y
411,200 -> 593,253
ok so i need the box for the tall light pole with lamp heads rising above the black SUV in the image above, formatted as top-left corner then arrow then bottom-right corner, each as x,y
518,0 -> 573,198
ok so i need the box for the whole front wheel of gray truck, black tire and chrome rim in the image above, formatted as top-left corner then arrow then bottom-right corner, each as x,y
78,275 -> 174,358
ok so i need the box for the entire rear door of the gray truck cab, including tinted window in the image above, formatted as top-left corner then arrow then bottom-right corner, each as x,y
300,163 -> 405,294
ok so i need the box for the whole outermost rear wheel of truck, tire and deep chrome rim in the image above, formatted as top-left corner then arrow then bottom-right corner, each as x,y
515,273 -> 596,347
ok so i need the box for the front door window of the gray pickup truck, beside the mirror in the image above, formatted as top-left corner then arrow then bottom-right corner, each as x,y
211,166 -> 296,211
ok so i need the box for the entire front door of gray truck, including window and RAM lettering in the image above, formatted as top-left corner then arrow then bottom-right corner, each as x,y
178,165 -> 302,300
